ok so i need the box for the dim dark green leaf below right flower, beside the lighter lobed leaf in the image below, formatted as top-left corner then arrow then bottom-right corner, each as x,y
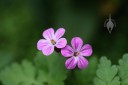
75,56 -> 98,85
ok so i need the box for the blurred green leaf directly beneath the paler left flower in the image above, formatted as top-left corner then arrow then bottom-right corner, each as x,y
35,52 -> 67,85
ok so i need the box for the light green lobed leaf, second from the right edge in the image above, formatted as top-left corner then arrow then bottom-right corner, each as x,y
94,57 -> 120,85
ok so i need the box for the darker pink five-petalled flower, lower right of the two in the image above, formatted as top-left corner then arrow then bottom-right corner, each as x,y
61,37 -> 92,69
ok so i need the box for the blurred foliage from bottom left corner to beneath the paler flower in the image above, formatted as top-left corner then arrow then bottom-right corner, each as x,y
0,53 -> 67,85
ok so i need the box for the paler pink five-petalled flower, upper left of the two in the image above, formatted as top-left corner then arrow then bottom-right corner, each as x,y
37,28 -> 67,56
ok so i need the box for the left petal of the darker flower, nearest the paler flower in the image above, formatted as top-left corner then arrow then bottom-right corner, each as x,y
61,45 -> 74,57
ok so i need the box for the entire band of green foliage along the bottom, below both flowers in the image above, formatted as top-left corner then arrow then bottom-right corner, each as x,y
0,52 -> 128,85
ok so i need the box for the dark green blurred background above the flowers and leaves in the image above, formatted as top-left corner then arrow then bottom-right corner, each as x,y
0,0 -> 128,73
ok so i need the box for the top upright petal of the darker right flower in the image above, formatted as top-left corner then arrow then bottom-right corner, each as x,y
71,37 -> 83,51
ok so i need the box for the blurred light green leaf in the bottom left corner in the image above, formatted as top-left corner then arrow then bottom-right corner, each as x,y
0,60 -> 42,85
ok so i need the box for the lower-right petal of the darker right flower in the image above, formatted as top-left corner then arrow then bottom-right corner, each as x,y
78,56 -> 88,69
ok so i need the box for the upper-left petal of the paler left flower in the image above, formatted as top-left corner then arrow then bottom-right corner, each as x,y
43,28 -> 54,40
